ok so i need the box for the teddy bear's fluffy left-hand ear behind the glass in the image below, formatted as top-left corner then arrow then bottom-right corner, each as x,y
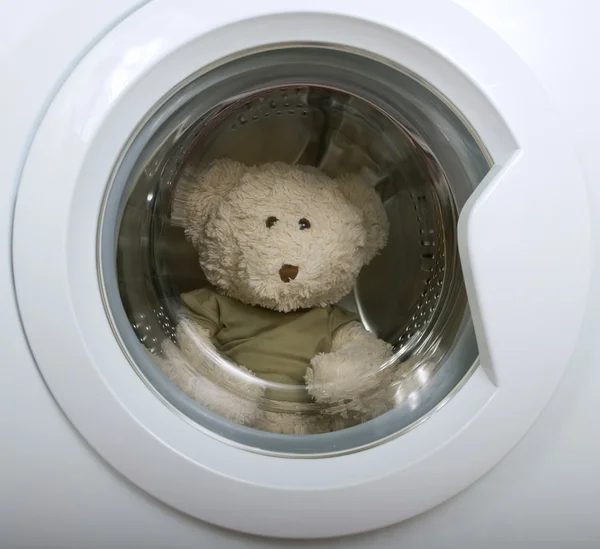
171,159 -> 248,244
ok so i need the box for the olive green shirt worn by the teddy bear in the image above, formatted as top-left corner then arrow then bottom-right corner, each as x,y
181,288 -> 357,385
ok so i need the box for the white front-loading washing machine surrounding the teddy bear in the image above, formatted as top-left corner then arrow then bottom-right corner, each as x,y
0,0 -> 600,549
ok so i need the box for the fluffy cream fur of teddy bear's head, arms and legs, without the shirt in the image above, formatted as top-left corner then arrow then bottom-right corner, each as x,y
161,160 -> 392,434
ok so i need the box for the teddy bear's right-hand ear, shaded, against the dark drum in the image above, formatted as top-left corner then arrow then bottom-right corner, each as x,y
336,174 -> 390,265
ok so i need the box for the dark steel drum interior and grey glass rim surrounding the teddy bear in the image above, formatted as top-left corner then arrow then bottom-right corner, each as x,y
99,45 -> 491,455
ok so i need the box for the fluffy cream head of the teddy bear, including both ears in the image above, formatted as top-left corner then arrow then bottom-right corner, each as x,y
171,159 -> 388,312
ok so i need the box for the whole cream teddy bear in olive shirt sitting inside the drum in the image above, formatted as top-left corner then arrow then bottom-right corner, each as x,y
160,159 -> 394,434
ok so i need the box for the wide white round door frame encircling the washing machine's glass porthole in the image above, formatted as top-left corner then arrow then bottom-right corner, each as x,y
13,0 -> 590,538
